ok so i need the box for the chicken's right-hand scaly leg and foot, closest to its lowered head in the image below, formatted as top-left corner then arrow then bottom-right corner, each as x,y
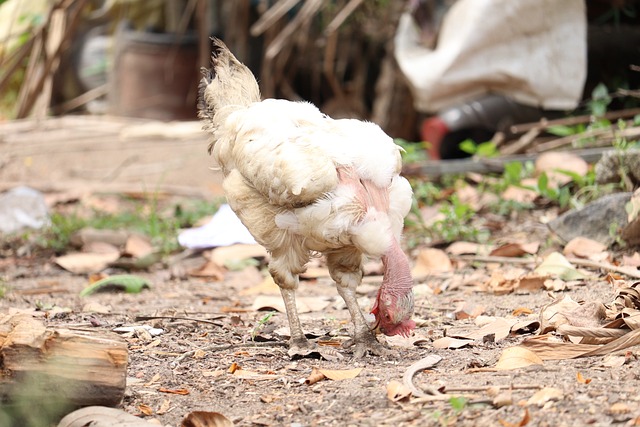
327,251 -> 391,358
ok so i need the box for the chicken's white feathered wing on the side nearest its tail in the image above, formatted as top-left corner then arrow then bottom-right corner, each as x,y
214,100 -> 338,208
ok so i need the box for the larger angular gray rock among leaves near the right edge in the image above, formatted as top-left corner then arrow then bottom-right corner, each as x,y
548,193 -> 633,246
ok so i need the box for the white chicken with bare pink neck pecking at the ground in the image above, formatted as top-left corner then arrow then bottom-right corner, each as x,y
198,39 -> 415,357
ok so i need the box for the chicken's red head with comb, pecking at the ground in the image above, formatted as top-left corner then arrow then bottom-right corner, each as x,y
371,288 -> 416,337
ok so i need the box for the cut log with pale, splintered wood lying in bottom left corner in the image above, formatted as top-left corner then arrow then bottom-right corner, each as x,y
0,313 -> 128,407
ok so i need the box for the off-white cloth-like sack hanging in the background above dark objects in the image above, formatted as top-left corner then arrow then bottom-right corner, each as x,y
395,0 -> 587,113
